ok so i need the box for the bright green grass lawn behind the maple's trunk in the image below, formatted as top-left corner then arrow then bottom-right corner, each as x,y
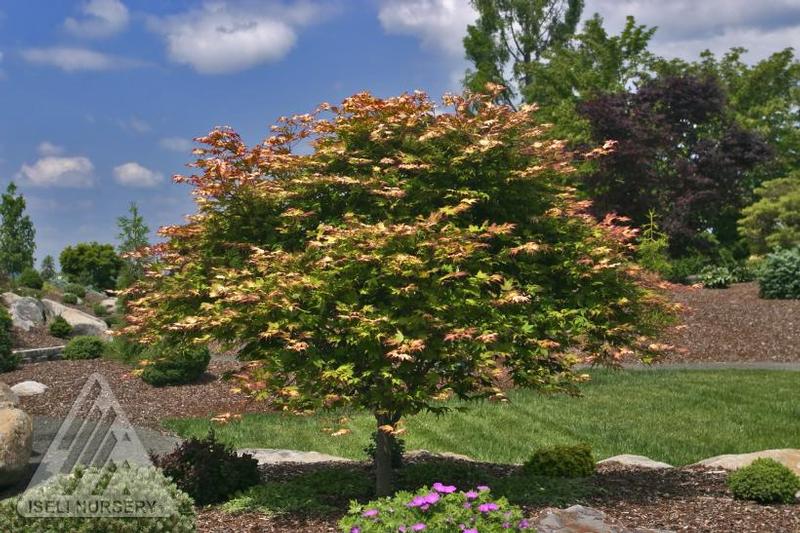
164,370 -> 800,465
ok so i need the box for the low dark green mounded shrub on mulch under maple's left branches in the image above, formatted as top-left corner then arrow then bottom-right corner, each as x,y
141,341 -> 211,387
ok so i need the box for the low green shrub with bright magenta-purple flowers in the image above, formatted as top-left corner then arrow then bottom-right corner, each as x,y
339,483 -> 532,533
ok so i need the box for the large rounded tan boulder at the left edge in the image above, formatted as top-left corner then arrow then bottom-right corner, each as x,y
0,407 -> 33,487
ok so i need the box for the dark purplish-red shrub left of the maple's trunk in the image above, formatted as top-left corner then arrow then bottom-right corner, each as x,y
152,432 -> 261,505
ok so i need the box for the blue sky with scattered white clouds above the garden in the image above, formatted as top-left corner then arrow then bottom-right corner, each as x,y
0,0 -> 800,266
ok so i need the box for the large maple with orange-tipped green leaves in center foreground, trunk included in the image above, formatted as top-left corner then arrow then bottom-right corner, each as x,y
121,93 -> 662,495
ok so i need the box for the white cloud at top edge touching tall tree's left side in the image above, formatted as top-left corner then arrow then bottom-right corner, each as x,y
378,0 -> 477,58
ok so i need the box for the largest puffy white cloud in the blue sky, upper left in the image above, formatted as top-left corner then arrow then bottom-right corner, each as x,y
150,2 -> 328,74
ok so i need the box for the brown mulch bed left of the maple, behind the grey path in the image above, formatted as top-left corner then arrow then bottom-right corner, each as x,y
0,359 -> 264,431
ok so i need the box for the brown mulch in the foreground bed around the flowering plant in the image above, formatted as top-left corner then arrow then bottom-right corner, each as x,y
198,465 -> 800,533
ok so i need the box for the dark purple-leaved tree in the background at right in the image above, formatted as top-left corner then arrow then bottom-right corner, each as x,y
580,76 -> 770,254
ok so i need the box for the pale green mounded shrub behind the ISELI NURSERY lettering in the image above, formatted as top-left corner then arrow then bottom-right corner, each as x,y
0,466 -> 196,533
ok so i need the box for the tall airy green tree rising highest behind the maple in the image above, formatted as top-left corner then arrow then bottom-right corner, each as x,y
464,0 -> 584,104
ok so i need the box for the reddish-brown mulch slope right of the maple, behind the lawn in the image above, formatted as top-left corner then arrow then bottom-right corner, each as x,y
662,283 -> 800,363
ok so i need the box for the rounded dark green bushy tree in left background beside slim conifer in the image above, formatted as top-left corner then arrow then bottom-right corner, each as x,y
59,242 -> 122,289
